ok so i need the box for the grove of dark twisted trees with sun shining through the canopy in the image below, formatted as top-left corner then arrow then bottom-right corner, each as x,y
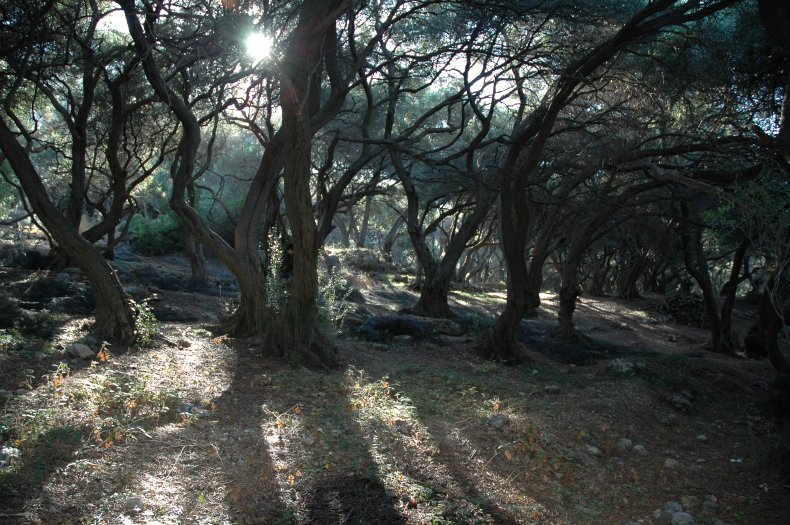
0,0 -> 790,373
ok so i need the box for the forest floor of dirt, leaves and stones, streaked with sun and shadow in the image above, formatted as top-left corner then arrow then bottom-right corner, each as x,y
0,248 -> 790,525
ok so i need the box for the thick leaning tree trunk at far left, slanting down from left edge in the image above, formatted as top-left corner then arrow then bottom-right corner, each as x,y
0,118 -> 135,344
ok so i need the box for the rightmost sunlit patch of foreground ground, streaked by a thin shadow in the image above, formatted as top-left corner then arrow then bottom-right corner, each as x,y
346,370 -> 557,523
